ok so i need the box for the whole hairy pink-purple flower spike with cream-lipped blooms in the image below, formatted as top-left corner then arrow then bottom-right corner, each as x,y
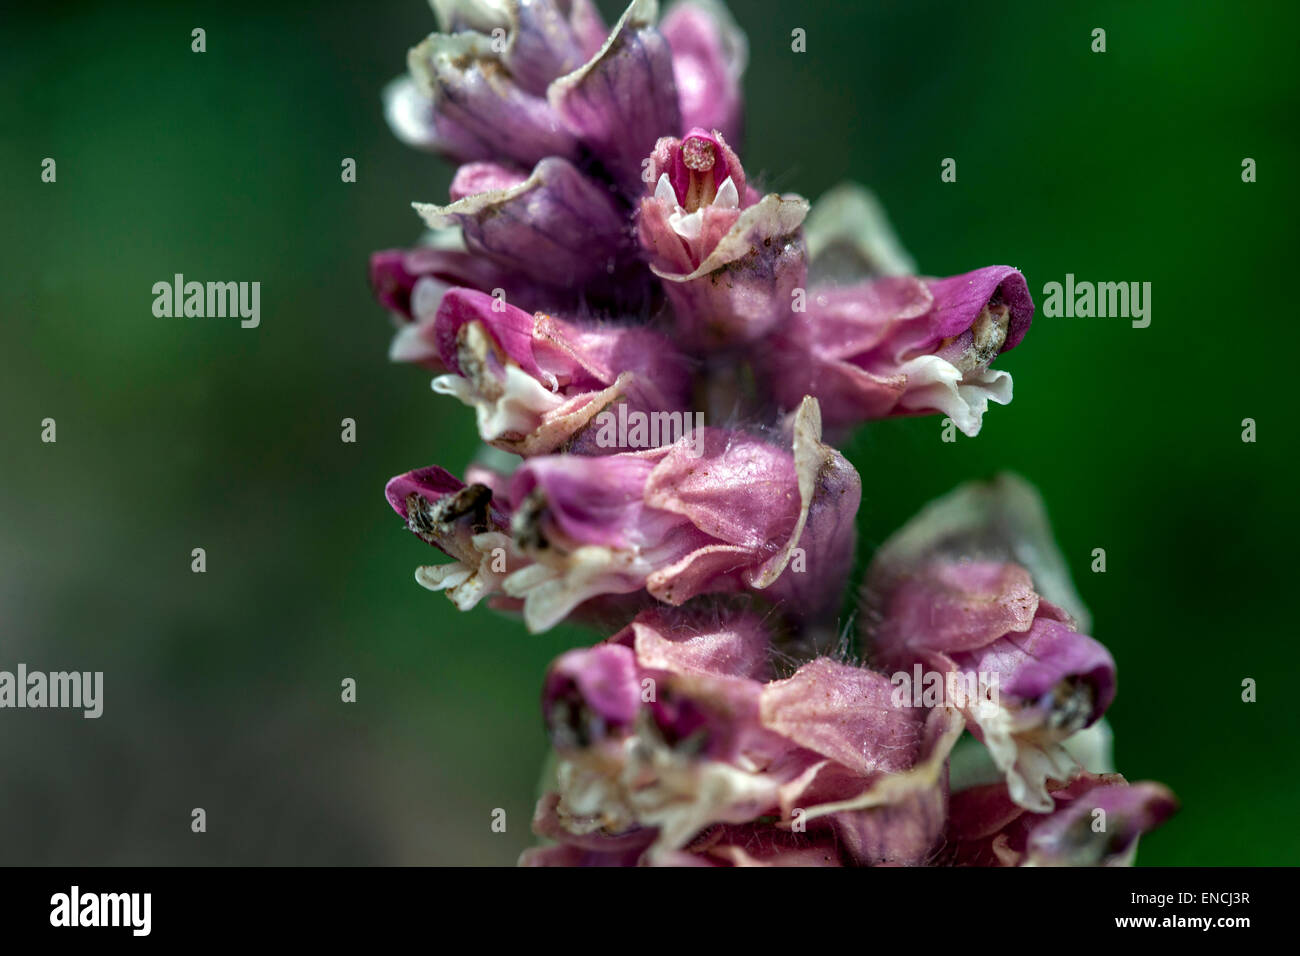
371,0 -> 1175,865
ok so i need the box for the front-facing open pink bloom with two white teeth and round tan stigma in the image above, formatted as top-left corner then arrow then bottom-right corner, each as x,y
638,129 -> 809,349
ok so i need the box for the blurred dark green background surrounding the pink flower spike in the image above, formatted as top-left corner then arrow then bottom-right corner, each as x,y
0,0 -> 1300,865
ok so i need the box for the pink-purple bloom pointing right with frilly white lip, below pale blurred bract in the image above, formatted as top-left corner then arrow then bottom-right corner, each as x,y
766,265 -> 1034,436
